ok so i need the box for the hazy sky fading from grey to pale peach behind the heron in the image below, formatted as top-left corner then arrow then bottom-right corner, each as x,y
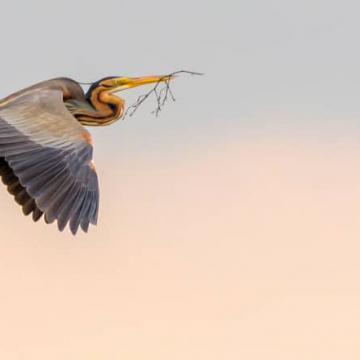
0,0 -> 360,360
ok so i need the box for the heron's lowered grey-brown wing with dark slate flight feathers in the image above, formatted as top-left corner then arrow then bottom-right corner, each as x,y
0,86 -> 99,234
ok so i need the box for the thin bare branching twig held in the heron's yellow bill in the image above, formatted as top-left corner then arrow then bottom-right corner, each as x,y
122,70 -> 203,119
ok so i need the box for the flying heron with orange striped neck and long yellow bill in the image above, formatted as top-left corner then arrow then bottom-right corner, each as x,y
0,75 -> 173,235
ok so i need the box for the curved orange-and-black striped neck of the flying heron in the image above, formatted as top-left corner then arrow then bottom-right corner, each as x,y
76,87 -> 125,126
